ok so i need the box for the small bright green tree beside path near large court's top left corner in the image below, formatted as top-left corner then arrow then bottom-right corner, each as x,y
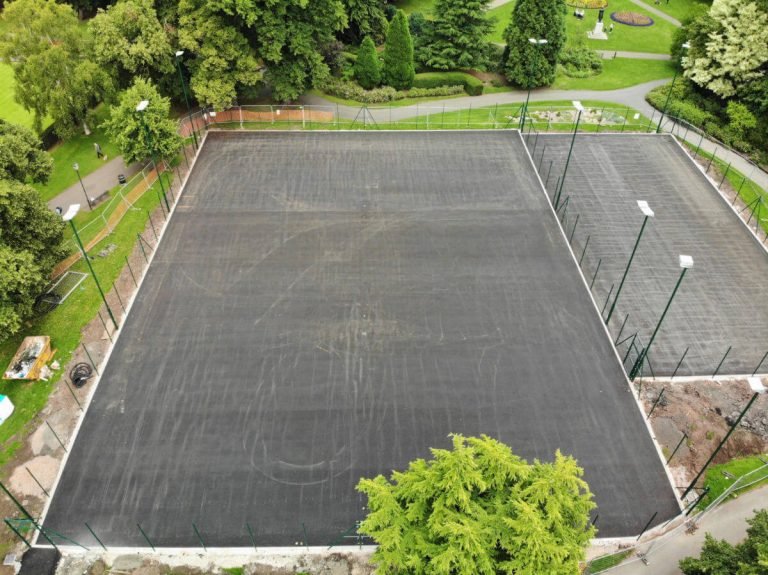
104,78 -> 182,164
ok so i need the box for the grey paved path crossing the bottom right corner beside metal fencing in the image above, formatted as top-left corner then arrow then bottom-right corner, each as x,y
605,486 -> 768,575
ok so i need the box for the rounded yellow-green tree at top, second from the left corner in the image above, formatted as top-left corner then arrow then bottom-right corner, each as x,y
88,0 -> 174,88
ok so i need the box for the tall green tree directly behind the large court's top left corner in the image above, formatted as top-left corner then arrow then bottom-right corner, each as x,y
179,0 -> 262,109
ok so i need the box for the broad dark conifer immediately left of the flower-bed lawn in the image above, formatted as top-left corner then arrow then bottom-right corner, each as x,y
502,0 -> 566,88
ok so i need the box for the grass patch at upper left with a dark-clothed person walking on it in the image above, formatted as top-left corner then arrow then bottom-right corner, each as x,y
34,105 -> 120,202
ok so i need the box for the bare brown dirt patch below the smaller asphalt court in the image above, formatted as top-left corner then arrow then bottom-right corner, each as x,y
640,378 -> 768,488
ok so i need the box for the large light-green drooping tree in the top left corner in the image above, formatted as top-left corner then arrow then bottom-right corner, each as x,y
0,0 -> 113,138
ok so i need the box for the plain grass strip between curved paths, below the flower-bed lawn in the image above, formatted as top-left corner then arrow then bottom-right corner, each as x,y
552,58 -> 675,90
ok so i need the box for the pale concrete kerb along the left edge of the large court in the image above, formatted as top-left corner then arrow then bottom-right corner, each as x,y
32,132 -> 208,551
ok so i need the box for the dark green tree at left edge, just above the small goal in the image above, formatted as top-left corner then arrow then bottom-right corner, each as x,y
0,180 -> 65,341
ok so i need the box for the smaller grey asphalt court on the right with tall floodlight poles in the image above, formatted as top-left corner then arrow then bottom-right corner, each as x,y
531,134 -> 768,376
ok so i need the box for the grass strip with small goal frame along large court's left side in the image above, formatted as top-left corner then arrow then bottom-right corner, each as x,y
0,177 -> 166,467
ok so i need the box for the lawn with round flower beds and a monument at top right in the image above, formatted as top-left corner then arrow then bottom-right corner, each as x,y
489,0 -> 675,54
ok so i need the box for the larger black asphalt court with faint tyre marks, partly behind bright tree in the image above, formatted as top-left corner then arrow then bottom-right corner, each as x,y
45,132 -> 678,546
